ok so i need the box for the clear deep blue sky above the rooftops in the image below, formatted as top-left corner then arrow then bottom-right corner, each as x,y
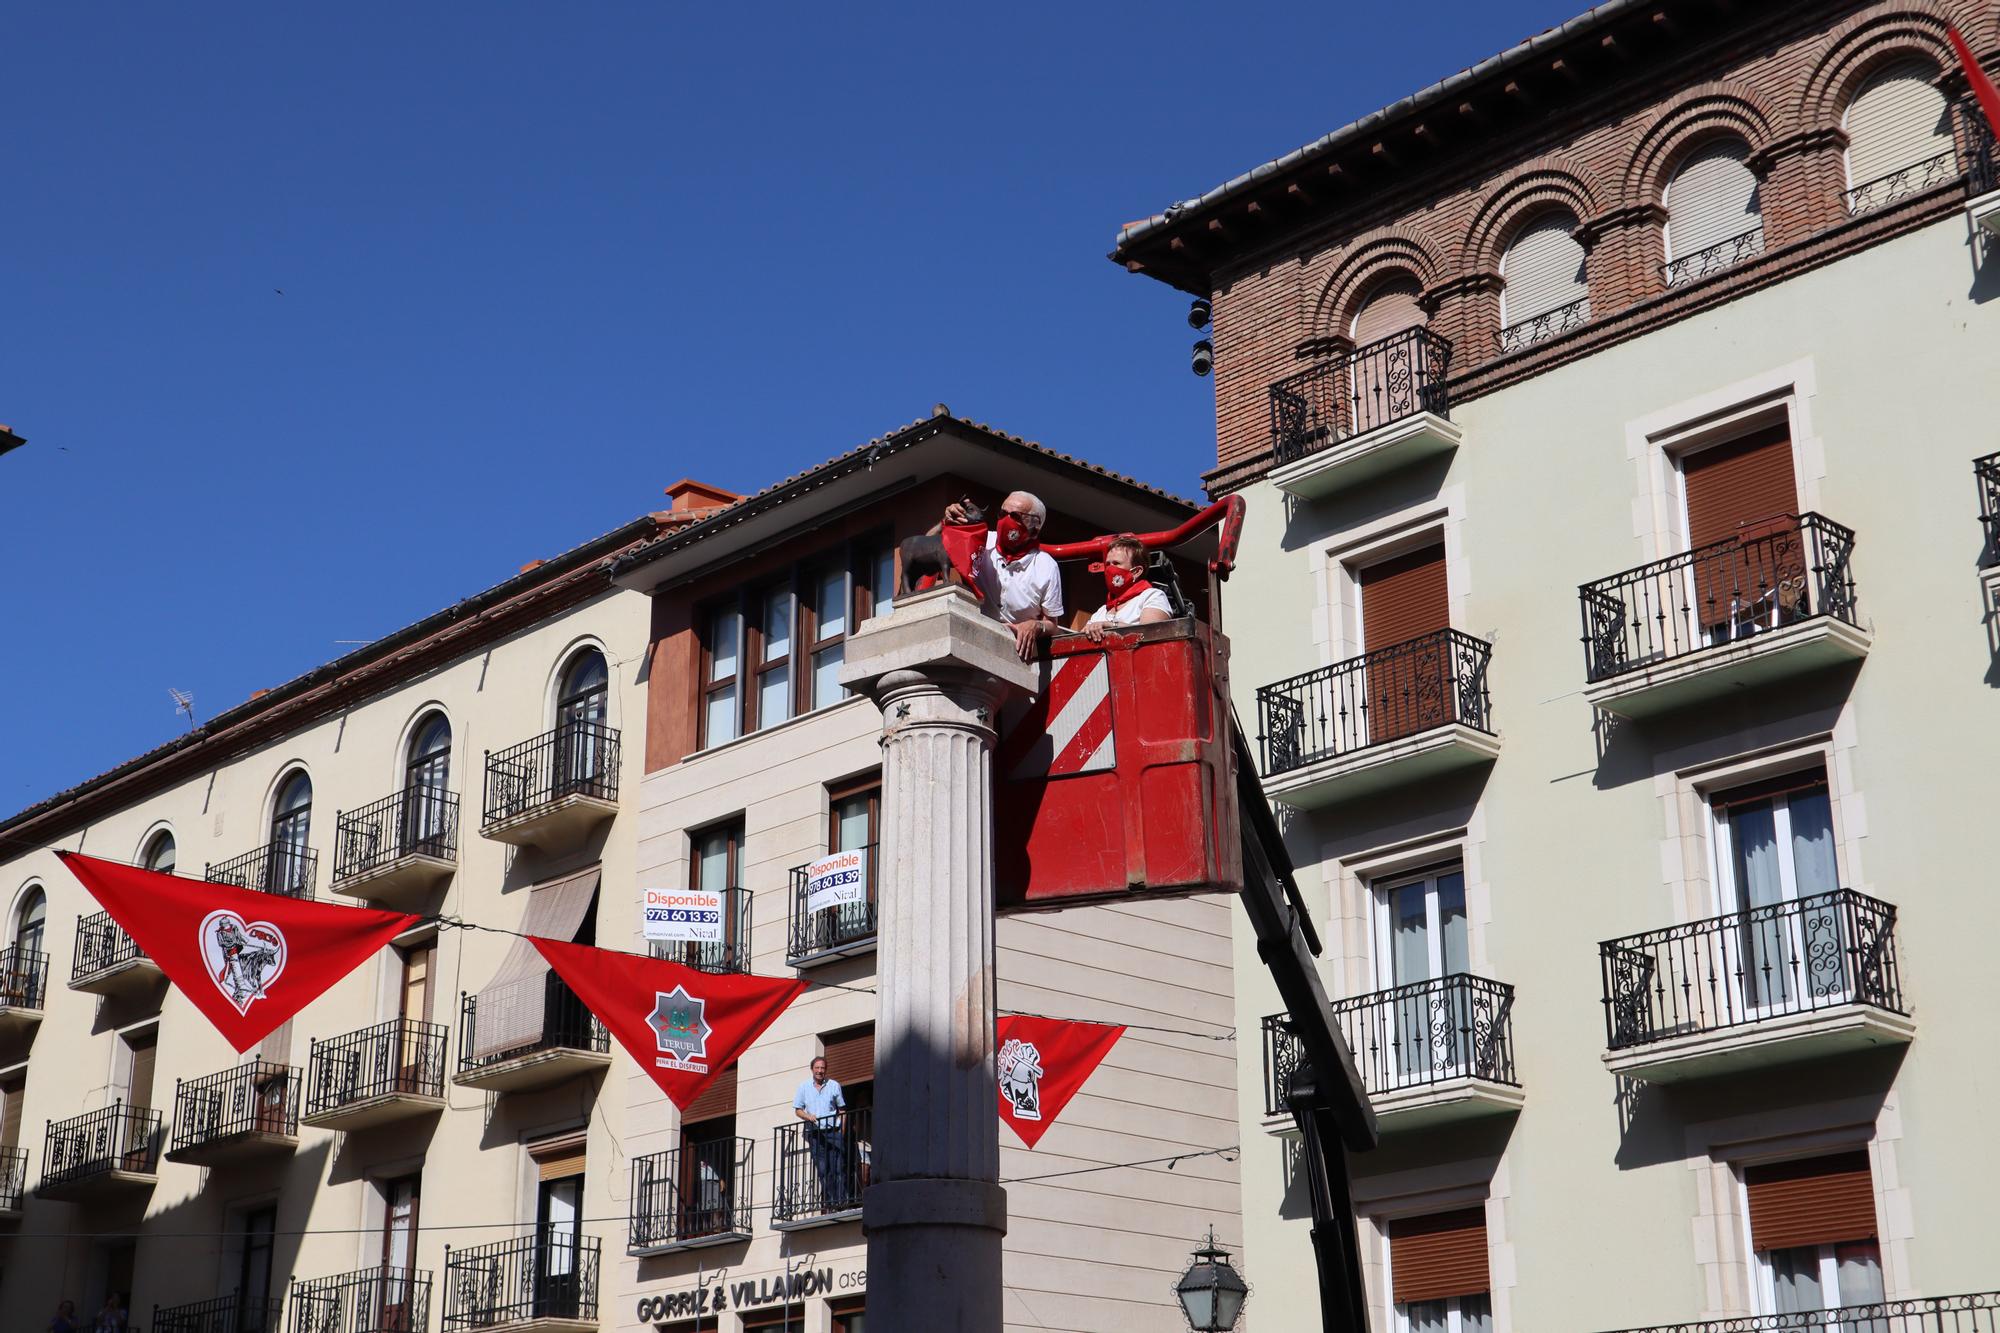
0,0 -> 1582,815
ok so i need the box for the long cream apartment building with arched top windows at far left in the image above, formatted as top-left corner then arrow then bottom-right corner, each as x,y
0,500 -> 734,1333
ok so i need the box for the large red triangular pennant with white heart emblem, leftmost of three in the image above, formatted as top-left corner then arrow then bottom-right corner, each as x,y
56,853 -> 422,1053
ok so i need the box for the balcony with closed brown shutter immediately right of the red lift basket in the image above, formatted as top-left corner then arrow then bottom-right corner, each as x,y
1256,630 -> 1500,809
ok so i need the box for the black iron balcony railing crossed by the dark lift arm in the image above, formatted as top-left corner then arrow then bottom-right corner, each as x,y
1264,973 -> 1518,1115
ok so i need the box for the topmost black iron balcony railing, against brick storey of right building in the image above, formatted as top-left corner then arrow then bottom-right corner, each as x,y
1270,328 -> 1452,466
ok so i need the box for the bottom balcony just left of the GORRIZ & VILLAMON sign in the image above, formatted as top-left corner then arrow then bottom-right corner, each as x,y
444,1229 -> 598,1333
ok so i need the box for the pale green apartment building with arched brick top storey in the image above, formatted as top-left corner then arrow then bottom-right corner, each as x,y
1114,0 -> 2000,1333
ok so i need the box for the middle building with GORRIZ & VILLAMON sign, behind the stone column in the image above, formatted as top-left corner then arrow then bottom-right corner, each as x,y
606,414 -> 1240,1333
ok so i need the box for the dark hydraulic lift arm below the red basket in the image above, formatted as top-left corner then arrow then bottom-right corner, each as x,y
1230,717 -> 1376,1333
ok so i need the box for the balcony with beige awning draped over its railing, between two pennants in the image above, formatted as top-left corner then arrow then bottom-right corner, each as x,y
452,973 -> 612,1093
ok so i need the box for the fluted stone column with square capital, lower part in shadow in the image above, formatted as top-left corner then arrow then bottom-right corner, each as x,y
840,586 -> 1036,1333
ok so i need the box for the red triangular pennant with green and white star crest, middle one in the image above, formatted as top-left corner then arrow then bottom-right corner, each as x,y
534,939 -> 806,1111
